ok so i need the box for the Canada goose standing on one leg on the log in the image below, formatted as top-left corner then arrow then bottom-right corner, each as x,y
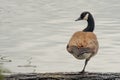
67,11 -> 99,73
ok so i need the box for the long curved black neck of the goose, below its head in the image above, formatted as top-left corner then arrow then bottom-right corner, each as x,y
83,15 -> 95,32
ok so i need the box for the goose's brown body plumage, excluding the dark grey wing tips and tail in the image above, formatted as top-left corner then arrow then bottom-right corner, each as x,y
67,31 -> 98,59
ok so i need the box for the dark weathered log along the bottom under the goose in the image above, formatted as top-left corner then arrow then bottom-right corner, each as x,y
5,72 -> 120,80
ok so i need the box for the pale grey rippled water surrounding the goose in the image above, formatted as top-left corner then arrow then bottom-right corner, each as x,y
0,0 -> 120,73
